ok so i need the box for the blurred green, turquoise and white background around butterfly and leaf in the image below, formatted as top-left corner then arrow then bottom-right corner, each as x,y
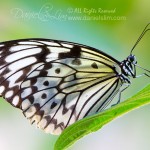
0,0 -> 150,150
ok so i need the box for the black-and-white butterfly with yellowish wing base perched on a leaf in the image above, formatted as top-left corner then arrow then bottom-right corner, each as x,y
0,25 -> 150,135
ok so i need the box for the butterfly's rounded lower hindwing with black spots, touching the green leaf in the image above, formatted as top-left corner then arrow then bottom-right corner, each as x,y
21,52 -> 119,134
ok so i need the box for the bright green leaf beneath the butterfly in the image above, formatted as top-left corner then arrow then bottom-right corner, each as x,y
55,84 -> 150,150
